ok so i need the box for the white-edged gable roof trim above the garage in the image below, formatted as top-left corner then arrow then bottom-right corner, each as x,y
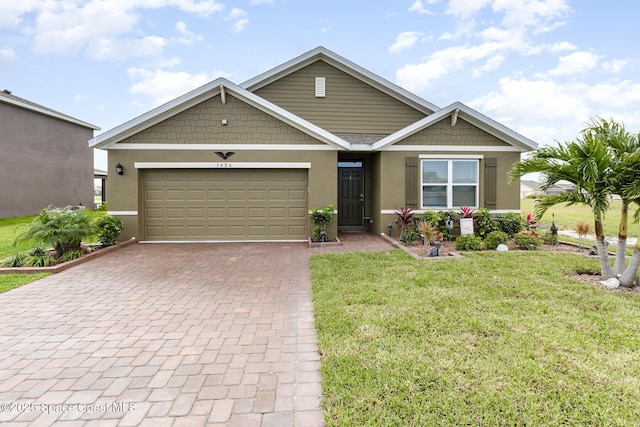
89,78 -> 349,149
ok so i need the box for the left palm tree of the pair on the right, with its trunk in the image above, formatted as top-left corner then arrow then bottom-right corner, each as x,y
509,133 -> 615,279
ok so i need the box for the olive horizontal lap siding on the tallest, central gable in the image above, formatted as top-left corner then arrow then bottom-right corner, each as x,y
254,61 -> 425,135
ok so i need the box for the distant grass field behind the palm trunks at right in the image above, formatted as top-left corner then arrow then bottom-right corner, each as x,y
520,199 -> 640,237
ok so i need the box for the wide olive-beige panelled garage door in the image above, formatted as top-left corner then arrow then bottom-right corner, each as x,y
143,169 -> 308,241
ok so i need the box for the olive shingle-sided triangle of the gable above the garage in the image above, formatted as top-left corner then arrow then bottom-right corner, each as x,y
119,94 -> 324,144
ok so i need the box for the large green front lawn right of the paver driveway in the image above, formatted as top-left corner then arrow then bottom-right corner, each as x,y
311,251 -> 640,426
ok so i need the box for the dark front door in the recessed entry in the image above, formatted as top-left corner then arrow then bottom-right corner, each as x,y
338,161 -> 364,227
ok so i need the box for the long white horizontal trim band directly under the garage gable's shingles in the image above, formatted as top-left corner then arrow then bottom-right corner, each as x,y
110,143 -> 339,151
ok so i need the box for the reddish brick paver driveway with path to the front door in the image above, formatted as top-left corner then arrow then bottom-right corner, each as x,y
0,234 -> 391,427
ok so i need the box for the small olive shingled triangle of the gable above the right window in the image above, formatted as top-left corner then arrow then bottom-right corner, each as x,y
396,117 -> 509,147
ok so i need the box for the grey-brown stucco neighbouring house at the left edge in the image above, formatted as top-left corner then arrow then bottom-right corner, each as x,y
0,90 -> 99,218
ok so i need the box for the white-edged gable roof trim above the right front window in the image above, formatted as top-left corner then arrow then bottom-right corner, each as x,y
372,102 -> 538,152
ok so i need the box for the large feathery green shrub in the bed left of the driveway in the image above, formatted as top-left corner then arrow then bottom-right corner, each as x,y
16,206 -> 95,258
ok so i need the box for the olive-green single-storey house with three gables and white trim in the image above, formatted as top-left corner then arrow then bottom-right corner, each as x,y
90,47 -> 536,241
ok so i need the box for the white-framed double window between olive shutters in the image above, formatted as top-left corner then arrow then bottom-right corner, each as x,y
420,159 -> 479,209
